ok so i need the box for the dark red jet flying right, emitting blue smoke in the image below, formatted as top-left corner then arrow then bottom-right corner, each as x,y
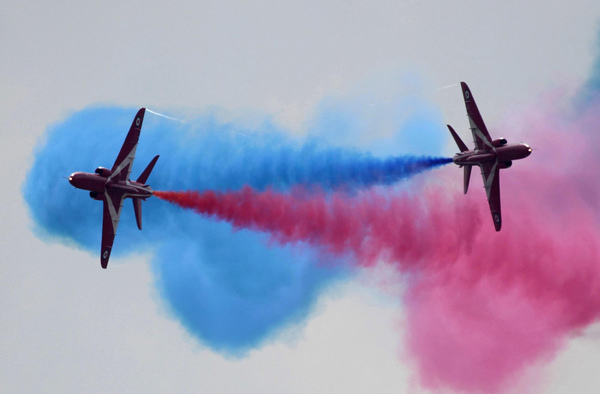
448,82 -> 531,231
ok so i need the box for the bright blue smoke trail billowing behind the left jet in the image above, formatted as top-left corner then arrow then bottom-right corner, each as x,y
23,100 -> 445,355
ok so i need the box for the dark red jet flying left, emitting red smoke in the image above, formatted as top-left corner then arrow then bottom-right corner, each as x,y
69,108 -> 158,268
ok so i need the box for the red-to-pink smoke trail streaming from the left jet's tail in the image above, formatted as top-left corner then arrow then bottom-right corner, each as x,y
156,96 -> 600,392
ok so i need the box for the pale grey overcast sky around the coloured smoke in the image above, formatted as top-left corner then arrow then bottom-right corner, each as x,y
0,0 -> 600,394
